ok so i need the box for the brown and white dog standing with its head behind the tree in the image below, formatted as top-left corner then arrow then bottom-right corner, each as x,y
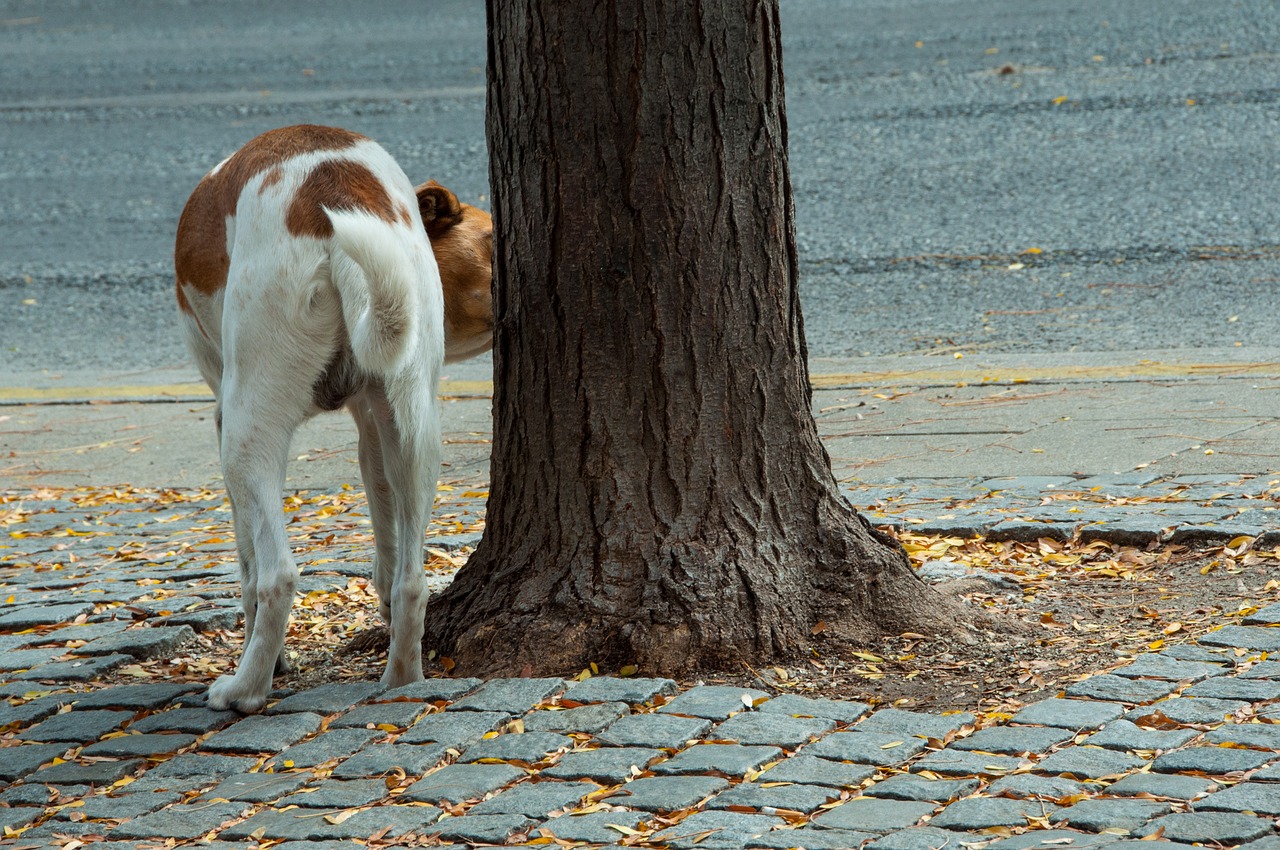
174,125 -> 493,712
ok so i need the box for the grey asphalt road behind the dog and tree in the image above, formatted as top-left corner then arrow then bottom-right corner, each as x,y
0,0 -> 1280,374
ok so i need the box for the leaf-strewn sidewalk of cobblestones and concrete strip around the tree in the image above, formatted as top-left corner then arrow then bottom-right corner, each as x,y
0,351 -> 1280,850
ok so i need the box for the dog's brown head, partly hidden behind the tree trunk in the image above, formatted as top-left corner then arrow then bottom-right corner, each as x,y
419,202 -> 493,361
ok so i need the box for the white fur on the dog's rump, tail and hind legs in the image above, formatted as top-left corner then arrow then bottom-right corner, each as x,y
182,136 -> 444,712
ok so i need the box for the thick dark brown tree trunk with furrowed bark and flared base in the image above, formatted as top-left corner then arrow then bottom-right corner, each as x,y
426,0 -> 962,675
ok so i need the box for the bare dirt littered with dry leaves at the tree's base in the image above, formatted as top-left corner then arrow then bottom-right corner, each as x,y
285,536 -> 1280,716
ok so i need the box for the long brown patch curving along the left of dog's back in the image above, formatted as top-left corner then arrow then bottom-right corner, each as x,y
173,124 -> 365,300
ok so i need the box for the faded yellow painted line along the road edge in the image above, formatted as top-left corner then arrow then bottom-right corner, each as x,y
0,362 -> 1280,405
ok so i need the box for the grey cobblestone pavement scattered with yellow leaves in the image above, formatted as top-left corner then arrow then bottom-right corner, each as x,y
0,476 -> 1280,850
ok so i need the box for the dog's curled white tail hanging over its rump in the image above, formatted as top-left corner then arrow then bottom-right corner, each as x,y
325,209 -> 415,374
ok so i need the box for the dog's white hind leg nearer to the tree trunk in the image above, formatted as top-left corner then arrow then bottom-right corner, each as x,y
366,369 -> 440,687
